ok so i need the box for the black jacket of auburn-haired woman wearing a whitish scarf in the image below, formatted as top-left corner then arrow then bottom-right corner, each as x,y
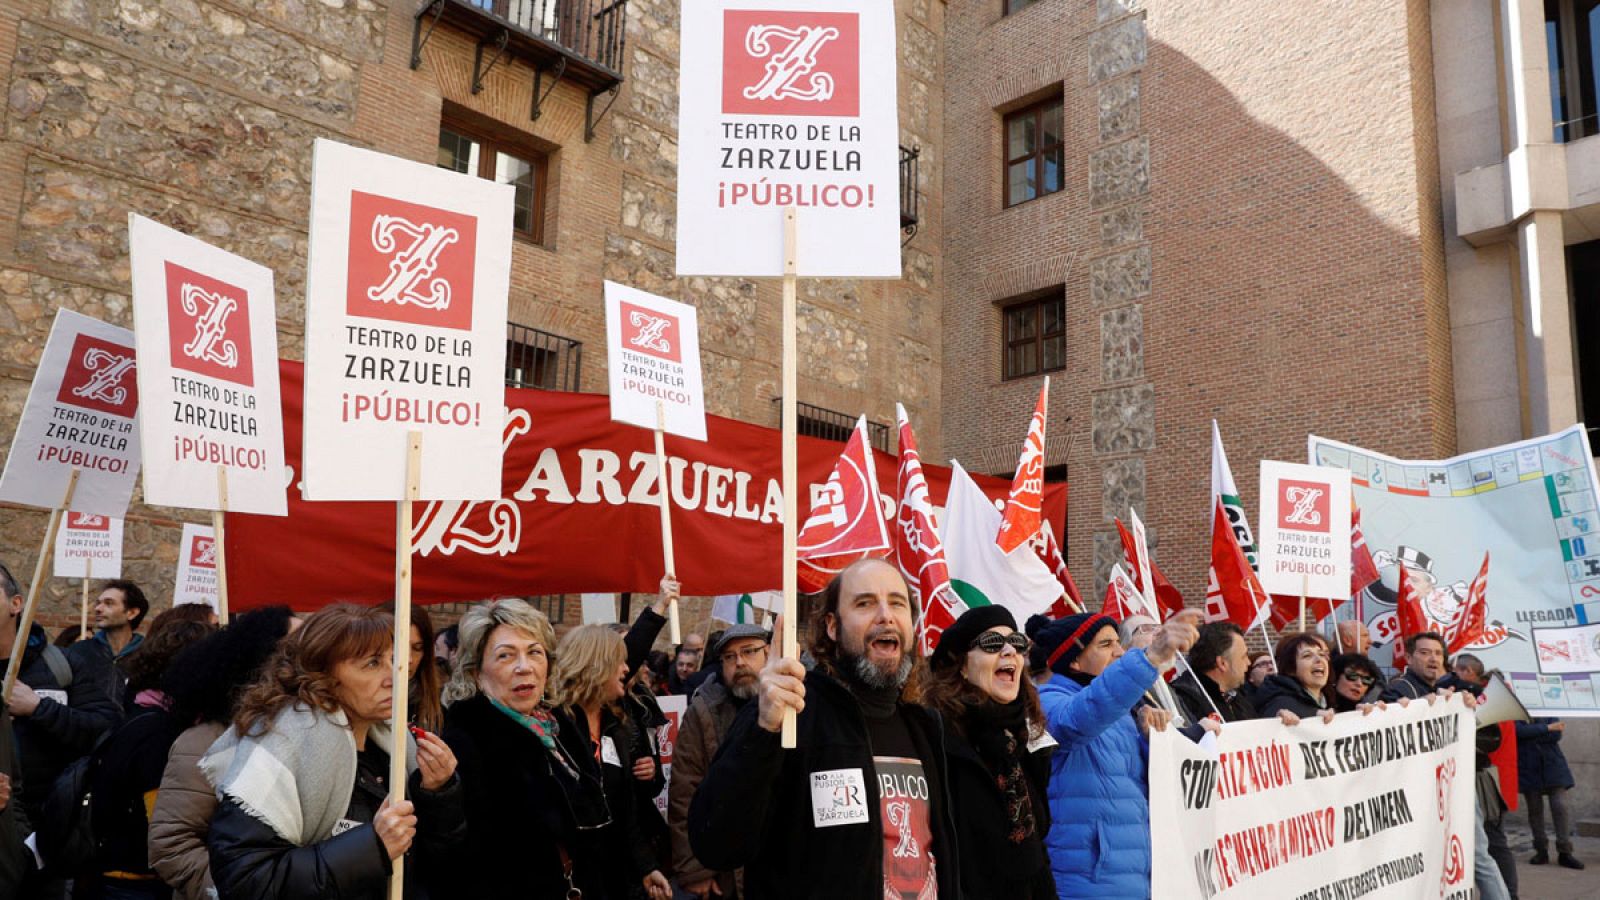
206,743 -> 464,900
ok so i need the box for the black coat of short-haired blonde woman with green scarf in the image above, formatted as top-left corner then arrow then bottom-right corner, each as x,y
443,695 -> 645,900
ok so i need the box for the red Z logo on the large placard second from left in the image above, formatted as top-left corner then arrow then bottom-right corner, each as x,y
165,259 -> 256,388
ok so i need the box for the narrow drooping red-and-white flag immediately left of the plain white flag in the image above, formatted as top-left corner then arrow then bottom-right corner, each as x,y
894,404 -> 966,657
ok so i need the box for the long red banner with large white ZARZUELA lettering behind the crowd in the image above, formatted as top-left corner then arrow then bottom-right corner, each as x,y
226,362 -> 1067,610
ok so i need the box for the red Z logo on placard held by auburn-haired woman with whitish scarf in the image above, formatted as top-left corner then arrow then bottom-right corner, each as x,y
346,191 -> 478,331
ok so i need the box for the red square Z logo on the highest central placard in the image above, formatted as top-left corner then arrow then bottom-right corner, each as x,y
722,10 -> 861,115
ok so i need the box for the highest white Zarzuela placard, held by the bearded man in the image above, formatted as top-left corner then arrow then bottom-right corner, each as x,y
677,0 -> 901,279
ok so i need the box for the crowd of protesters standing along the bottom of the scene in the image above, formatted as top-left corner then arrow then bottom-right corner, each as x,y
0,559 -> 1582,900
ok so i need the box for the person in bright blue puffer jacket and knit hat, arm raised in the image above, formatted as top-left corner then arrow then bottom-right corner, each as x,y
1027,612 -> 1198,900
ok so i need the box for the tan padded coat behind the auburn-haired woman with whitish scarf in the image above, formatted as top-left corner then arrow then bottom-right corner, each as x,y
149,722 -> 227,900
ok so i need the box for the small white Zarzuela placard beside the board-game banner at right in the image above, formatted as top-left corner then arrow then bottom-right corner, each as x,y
1256,460 -> 1350,601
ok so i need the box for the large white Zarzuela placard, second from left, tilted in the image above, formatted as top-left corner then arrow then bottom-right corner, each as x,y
128,215 -> 288,516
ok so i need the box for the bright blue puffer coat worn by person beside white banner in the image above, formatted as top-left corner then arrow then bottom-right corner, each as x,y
1038,650 -> 1158,900
